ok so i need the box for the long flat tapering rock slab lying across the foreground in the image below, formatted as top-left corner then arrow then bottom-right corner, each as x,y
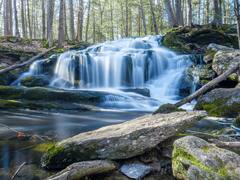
42,111 -> 205,169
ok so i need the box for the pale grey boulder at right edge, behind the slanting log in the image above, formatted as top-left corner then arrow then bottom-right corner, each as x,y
212,50 -> 240,82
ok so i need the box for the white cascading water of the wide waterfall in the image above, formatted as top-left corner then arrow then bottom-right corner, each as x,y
20,36 -> 195,111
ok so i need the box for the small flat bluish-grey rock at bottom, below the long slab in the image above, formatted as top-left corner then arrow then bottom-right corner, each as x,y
120,163 -> 152,180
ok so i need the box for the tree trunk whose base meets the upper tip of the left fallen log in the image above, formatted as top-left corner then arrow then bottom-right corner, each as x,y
58,0 -> 65,48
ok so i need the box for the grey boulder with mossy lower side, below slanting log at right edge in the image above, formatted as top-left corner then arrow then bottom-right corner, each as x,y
195,87 -> 240,117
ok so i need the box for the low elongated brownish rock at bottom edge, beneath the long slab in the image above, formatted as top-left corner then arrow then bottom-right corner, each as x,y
47,160 -> 116,180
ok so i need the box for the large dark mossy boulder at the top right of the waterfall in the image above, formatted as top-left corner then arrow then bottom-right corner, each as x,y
162,26 -> 238,53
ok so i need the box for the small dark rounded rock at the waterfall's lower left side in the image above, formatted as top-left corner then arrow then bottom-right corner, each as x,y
20,75 -> 50,87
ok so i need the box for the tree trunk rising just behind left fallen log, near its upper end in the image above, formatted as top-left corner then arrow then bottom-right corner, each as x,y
47,0 -> 55,47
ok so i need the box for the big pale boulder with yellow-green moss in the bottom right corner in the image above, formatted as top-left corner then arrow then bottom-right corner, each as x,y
172,136 -> 240,180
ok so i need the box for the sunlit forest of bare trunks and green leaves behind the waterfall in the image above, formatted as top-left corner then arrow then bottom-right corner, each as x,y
0,0 -> 239,46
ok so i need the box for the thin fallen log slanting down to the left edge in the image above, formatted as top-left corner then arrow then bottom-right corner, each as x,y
0,47 -> 56,75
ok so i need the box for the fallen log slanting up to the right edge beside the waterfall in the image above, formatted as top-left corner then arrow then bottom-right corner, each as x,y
153,59 -> 240,114
